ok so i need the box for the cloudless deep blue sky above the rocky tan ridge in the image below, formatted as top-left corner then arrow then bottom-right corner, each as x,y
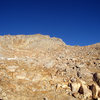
0,0 -> 100,46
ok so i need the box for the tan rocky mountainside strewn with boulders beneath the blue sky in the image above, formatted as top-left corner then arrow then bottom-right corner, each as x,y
0,34 -> 100,100
